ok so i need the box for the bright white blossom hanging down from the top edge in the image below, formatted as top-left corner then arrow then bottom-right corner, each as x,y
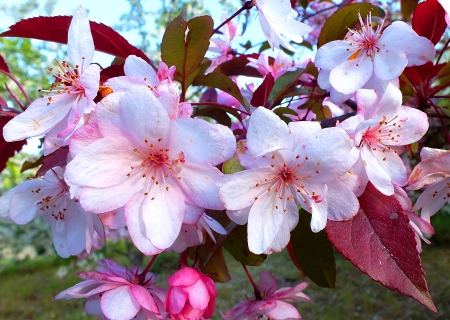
252,0 -> 312,51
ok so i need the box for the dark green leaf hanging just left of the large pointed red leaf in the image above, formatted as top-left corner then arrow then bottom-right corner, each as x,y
289,209 -> 336,288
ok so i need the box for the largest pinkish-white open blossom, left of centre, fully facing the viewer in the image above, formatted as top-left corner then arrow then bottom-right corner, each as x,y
66,86 -> 236,255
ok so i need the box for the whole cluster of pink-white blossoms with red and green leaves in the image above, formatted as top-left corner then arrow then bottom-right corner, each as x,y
0,0 -> 450,319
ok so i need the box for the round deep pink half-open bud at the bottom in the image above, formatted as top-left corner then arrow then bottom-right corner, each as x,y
164,267 -> 217,320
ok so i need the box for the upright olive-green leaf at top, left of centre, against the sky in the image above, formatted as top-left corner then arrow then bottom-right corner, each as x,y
161,10 -> 214,89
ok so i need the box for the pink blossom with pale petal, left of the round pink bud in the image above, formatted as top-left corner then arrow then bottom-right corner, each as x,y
53,259 -> 166,320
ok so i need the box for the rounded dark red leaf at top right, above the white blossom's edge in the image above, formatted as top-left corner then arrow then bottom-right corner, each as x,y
411,0 -> 447,44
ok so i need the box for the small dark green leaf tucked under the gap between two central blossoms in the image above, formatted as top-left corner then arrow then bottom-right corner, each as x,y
223,225 -> 267,266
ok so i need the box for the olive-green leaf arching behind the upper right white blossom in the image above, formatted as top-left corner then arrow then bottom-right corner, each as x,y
317,3 -> 386,48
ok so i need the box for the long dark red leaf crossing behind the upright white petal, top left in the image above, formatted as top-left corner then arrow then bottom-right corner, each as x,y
0,16 -> 150,63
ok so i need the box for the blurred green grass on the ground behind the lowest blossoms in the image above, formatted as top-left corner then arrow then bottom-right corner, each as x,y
0,246 -> 450,320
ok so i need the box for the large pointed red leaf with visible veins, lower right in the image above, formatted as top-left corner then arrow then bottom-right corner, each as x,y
325,183 -> 437,312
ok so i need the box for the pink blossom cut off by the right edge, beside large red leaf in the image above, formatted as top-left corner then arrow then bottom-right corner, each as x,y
406,147 -> 450,222
